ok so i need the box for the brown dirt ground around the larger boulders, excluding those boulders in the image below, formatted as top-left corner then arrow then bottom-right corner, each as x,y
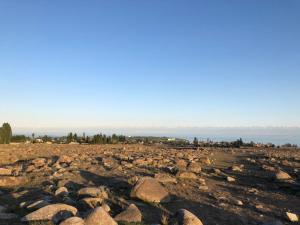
0,144 -> 300,225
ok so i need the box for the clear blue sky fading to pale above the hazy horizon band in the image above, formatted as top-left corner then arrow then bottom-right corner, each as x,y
0,0 -> 300,127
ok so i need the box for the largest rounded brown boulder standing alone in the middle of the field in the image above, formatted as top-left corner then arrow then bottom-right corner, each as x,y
130,177 -> 170,203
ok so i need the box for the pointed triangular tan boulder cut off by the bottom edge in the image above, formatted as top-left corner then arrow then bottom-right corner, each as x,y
85,207 -> 118,225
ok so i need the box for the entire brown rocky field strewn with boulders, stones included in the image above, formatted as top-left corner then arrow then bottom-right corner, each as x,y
0,144 -> 300,225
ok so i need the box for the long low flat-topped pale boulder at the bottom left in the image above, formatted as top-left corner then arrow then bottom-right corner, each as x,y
22,203 -> 77,223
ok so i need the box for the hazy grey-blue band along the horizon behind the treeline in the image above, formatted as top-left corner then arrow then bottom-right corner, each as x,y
14,127 -> 300,145
